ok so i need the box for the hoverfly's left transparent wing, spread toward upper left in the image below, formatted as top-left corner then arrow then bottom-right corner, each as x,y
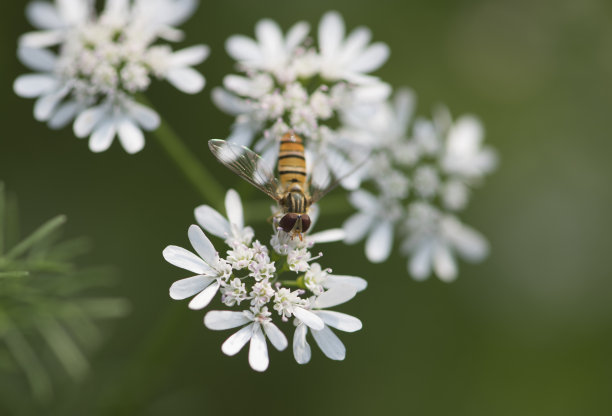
208,140 -> 280,200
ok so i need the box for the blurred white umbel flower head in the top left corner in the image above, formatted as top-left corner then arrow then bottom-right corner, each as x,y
13,0 -> 208,153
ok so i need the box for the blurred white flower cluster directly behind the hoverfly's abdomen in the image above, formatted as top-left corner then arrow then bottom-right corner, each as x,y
213,12 -> 390,187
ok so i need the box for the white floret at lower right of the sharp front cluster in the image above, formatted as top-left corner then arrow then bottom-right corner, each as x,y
293,286 -> 362,364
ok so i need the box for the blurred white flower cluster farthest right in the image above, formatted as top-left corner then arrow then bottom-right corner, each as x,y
343,90 -> 497,281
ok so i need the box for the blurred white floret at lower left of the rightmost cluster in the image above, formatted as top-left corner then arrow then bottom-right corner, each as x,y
342,190 -> 402,263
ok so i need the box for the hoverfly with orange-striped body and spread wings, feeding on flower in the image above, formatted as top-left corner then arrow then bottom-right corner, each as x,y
208,132 -> 360,240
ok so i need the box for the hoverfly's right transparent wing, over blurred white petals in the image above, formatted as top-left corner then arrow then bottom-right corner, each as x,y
310,149 -> 369,204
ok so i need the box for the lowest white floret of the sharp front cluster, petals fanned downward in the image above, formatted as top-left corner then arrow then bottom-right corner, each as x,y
204,306 -> 288,371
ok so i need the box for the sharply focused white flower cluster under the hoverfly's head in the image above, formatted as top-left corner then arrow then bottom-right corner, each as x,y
163,190 -> 366,371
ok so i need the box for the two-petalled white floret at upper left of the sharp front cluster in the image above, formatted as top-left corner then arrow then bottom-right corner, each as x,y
194,189 -> 254,246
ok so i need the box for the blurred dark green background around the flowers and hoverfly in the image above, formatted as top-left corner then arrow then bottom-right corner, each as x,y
0,0 -> 612,416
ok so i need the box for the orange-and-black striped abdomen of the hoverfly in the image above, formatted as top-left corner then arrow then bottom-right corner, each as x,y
278,133 -> 306,190
